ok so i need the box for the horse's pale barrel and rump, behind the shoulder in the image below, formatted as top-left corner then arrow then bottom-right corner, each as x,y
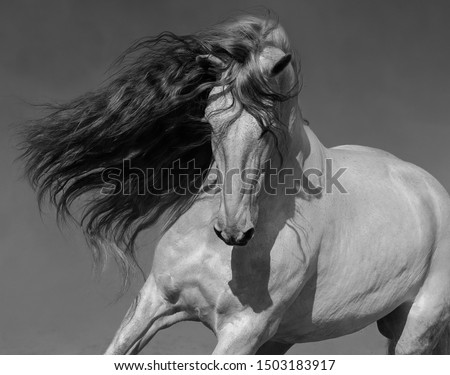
276,136 -> 450,342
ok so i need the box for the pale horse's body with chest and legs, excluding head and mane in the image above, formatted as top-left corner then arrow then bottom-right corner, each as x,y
104,123 -> 450,353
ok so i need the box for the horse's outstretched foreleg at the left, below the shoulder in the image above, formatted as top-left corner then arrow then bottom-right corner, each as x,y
105,275 -> 189,354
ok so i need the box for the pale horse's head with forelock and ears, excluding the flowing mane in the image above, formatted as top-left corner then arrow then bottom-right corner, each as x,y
205,46 -> 295,246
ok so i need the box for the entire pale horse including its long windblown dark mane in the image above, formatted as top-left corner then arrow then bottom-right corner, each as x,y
22,14 -> 450,354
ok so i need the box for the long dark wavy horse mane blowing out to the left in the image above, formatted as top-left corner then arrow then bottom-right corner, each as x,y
20,14 -> 298,283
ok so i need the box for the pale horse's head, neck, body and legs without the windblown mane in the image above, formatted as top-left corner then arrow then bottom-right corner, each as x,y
22,16 -> 450,354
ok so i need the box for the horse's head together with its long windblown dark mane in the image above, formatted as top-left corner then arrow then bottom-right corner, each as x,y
21,15 -> 299,283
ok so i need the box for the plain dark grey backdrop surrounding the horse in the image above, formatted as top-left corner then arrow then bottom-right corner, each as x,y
0,0 -> 450,354
